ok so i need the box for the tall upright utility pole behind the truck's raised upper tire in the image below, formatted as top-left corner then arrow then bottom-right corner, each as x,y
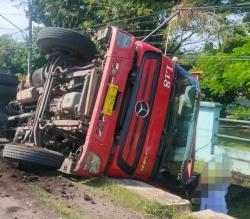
28,0 -> 32,77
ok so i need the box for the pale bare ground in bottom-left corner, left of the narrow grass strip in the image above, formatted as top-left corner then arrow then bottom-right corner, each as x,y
0,152 -> 61,219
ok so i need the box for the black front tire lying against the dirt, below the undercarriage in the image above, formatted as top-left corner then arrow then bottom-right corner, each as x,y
3,143 -> 64,169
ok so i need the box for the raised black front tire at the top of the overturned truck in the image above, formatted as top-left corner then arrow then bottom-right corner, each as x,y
37,27 -> 96,60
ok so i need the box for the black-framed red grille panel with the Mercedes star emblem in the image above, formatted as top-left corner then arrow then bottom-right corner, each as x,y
118,52 -> 162,175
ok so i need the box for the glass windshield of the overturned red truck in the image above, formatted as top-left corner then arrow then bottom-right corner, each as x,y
165,66 -> 199,180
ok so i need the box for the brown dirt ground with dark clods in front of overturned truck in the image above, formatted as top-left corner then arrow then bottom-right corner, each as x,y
0,149 -> 144,219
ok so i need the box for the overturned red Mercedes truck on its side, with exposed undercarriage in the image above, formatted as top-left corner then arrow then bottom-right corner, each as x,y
3,27 -> 200,190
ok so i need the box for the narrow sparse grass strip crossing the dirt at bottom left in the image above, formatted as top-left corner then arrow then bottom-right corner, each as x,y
31,186 -> 83,219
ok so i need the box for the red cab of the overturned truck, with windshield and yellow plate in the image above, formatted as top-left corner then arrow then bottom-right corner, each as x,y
69,27 -> 200,186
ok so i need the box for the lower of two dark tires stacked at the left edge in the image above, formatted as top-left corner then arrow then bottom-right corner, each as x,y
0,85 -> 17,104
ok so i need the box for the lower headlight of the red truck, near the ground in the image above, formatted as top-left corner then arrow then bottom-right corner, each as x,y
83,152 -> 101,174
